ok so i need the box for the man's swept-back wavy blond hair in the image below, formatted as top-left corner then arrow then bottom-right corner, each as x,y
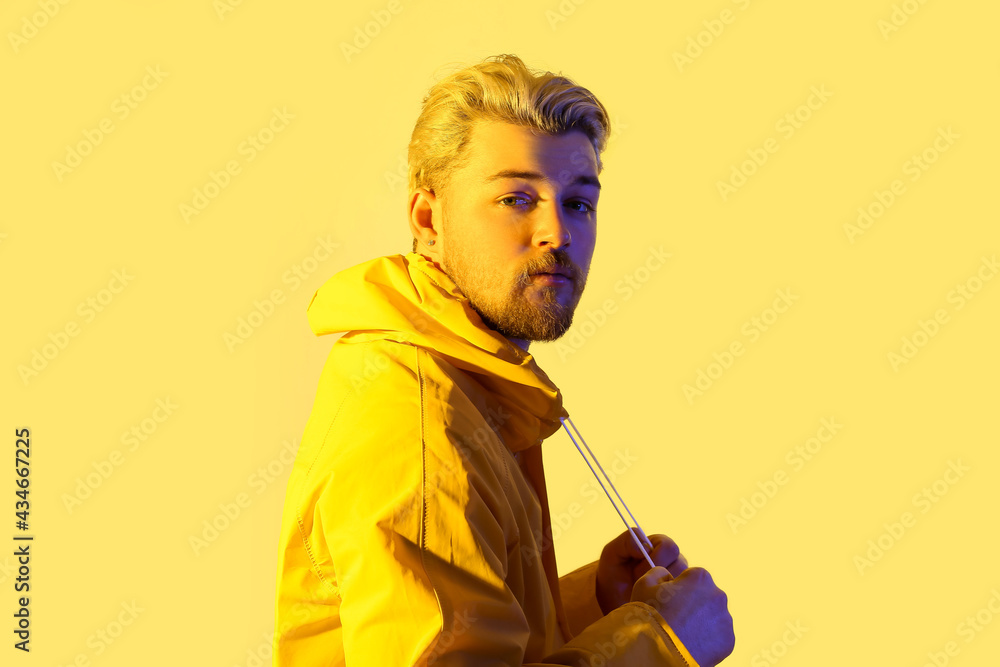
407,54 -> 610,252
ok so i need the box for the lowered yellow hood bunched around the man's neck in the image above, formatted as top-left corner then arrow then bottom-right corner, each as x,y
307,252 -> 568,451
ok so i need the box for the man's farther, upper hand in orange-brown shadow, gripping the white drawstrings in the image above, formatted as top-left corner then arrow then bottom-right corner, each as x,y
597,530 -> 687,614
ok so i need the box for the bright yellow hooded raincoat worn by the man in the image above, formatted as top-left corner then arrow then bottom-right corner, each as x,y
273,252 -> 696,667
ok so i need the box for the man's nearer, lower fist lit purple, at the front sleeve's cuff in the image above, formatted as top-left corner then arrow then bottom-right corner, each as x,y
632,564 -> 736,667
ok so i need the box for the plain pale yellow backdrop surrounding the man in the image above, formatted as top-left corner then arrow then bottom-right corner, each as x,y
0,0 -> 1000,667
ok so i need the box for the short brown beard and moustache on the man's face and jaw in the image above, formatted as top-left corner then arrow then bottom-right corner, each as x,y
441,210 -> 586,341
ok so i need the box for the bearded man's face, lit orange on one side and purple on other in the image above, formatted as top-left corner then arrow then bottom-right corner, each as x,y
438,121 -> 600,348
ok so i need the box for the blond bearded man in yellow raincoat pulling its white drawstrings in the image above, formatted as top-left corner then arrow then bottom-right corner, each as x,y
274,56 -> 734,667
